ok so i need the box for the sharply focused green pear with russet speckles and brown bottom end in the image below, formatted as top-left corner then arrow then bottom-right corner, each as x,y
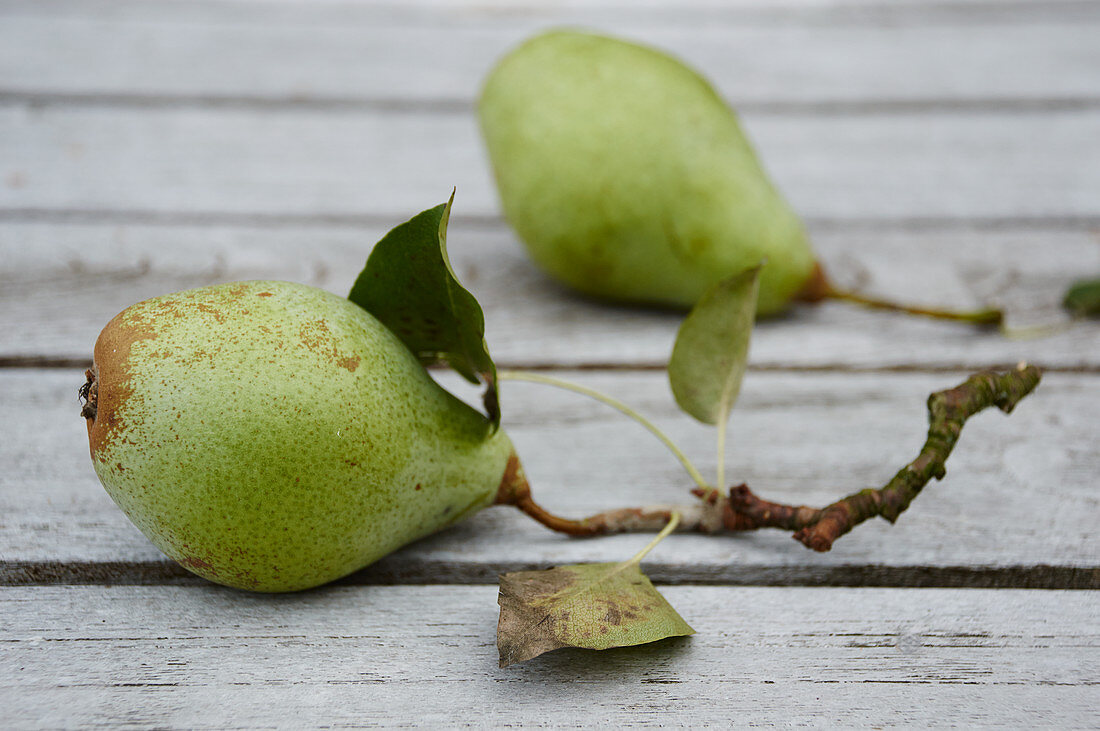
88,281 -> 518,591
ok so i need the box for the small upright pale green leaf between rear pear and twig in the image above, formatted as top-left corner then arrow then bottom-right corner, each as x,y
669,264 -> 763,424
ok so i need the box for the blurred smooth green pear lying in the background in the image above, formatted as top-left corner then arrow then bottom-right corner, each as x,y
479,31 -> 814,314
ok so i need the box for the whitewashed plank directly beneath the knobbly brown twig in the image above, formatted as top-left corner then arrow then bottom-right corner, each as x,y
0,369 -> 1100,586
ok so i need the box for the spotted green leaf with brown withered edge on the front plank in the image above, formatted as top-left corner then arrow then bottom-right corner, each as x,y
496,561 -> 695,667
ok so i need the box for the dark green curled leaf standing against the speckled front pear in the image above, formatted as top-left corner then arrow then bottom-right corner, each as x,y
348,191 -> 501,429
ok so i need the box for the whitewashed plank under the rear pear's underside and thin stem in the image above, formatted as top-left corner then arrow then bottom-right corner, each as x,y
0,217 -> 1100,368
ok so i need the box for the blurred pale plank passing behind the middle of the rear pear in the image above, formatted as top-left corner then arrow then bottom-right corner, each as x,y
0,106 -> 1100,220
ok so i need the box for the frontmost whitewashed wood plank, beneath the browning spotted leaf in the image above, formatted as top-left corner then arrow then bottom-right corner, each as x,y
0,587 -> 1100,729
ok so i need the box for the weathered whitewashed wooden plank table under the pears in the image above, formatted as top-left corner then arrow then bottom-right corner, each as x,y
0,0 -> 1100,728
